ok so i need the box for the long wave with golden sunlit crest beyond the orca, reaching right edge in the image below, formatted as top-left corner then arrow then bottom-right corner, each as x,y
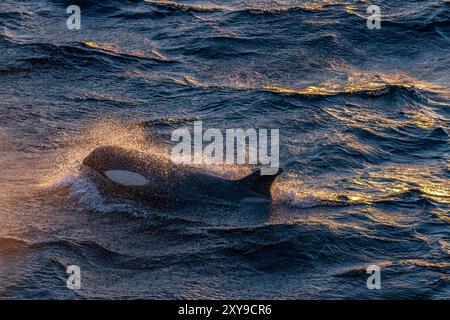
137,67 -> 450,103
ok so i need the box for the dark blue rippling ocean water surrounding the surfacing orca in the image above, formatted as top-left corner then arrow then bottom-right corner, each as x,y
0,0 -> 450,299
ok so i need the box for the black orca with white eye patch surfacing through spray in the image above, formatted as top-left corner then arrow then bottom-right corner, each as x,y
82,146 -> 283,202
